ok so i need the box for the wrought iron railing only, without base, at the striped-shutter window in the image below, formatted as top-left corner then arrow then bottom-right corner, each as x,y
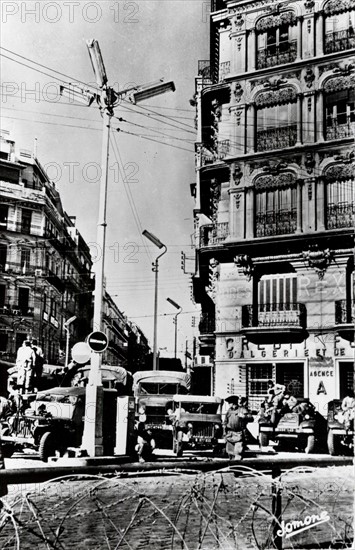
242,302 -> 306,328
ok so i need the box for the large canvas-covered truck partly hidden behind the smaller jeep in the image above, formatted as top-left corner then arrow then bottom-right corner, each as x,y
133,370 -> 191,449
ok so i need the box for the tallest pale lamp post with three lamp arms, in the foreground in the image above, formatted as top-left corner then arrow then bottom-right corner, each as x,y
60,39 -> 175,456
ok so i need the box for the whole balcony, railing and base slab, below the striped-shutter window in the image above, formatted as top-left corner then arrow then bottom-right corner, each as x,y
242,302 -> 306,341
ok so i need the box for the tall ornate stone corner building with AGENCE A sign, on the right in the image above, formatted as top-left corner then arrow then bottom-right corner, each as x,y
193,0 -> 355,414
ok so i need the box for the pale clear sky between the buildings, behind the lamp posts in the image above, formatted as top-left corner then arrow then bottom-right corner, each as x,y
0,0 -> 209,362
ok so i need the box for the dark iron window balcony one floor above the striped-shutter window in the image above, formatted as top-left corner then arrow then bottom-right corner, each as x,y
255,210 -> 297,237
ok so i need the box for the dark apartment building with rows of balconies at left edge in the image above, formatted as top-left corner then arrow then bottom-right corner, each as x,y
0,131 -> 93,364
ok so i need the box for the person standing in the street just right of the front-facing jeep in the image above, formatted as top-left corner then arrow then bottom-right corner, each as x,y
223,395 -> 253,460
